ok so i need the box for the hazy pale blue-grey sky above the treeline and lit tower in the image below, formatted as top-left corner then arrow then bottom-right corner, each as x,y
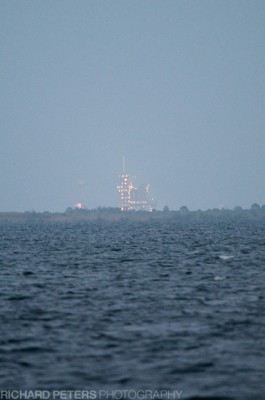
0,0 -> 265,211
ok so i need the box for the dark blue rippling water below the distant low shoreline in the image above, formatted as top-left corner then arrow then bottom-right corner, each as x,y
0,222 -> 265,400
